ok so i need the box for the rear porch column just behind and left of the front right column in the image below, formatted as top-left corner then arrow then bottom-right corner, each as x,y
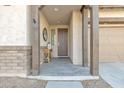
81,5 -> 88,67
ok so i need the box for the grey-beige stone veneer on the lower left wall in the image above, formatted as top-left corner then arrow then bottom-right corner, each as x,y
0,46 -> 31,76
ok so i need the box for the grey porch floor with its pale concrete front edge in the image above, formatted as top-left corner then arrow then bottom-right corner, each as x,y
28,57 -> 99,81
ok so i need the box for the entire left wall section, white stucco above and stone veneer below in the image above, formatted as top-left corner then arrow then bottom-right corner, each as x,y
0,5 -> 32,76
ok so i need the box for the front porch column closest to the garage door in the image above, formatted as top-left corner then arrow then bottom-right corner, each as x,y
90,5 -> 99,76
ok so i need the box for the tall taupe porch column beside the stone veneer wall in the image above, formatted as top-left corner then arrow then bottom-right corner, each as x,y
31,6 -> 40,75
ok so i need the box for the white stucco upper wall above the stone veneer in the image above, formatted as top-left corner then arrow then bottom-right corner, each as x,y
0,5 -> 30,46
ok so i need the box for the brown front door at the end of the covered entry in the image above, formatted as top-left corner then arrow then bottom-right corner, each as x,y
58,28 -> 68,56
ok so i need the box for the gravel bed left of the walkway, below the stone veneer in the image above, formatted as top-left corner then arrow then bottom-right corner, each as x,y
0,77 -> 47,88
